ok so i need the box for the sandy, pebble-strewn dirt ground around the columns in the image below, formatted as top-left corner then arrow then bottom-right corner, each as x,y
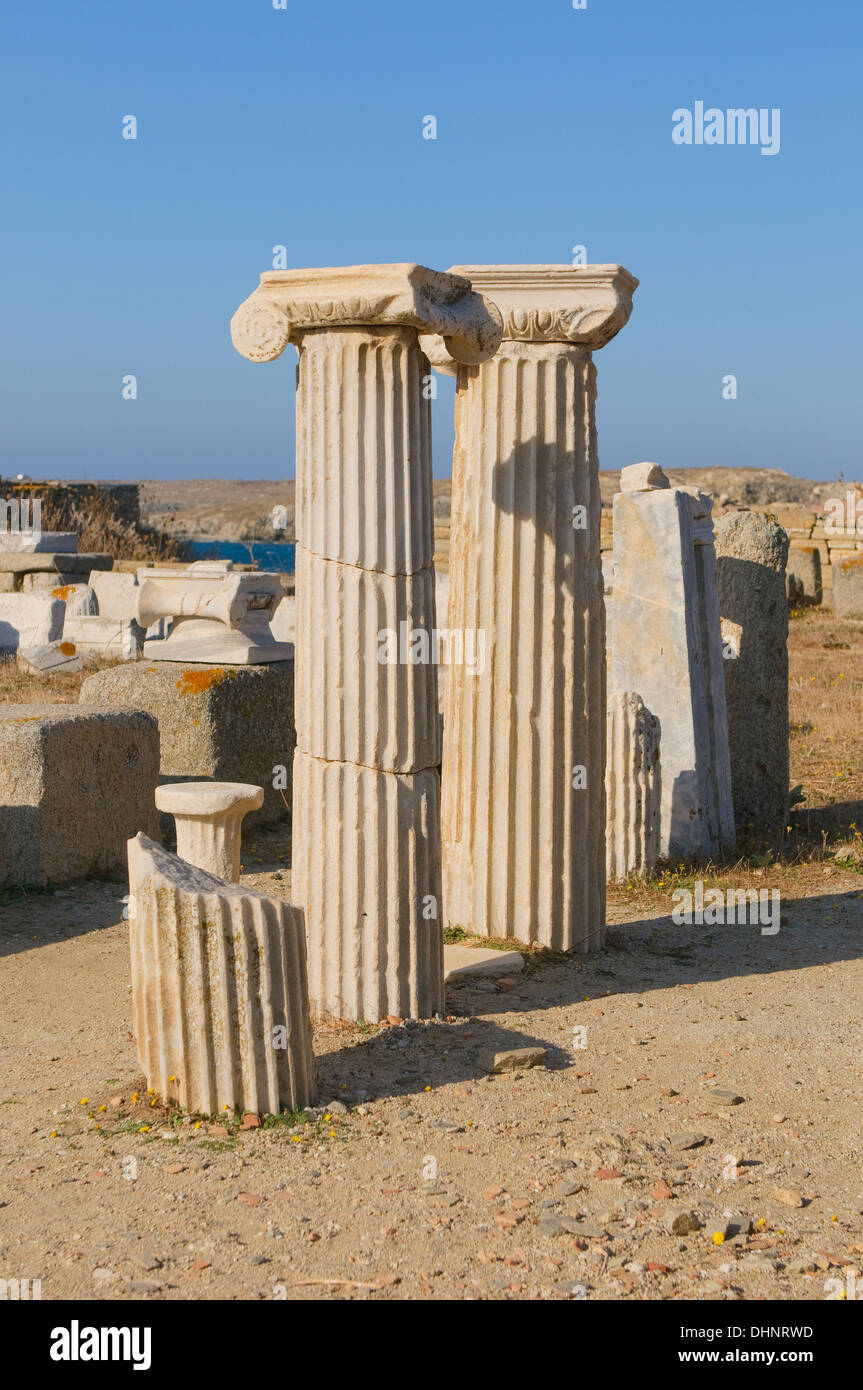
0,612 -> 863,1300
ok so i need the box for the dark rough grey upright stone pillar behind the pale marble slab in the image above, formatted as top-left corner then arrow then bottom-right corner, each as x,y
716,512 -> 789,835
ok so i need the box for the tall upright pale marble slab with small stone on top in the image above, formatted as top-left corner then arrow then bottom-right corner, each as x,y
609,464 -> 734,860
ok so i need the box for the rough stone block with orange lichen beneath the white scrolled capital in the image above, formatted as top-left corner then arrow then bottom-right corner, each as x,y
81,660 -> 295,826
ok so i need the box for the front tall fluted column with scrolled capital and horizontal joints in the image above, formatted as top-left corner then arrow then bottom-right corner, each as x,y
231,265 -> 500,1020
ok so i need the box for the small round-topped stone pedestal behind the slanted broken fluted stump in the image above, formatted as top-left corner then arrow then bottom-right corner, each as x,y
156,781 -> 264,883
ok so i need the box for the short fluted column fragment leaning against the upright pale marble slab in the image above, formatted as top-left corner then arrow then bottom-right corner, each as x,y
606,691 -> 661,878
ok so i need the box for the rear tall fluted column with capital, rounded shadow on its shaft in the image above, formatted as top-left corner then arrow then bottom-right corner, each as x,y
419,265 -> 638,952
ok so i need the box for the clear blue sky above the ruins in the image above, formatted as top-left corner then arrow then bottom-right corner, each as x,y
0,0 -> 863,478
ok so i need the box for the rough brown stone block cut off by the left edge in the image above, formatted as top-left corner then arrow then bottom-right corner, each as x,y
0,705 -> 158,887
